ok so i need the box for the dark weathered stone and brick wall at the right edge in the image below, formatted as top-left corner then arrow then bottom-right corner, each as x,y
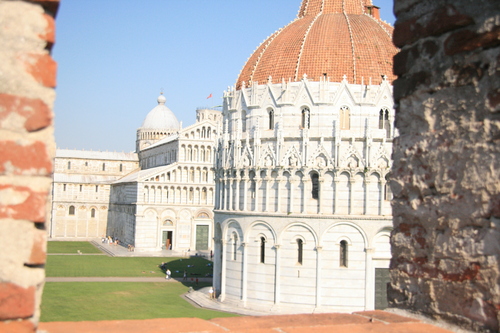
389,0 -> 500,332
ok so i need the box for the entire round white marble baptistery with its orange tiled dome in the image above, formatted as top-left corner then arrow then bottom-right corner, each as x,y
214,0 -> 397,313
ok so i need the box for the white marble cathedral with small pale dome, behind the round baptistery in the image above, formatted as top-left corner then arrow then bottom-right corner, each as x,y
48,95 -> 221,255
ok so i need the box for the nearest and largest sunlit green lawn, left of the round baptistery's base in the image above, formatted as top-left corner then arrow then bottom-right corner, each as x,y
40,282 -> 235,322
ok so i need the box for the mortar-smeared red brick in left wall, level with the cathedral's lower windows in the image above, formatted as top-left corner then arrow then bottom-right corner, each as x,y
0,185 -> 48,222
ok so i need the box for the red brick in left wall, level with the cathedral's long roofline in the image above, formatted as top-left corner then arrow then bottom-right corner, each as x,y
0,141 -> 52,176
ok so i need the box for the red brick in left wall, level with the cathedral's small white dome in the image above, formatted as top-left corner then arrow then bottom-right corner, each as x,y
0,94 -> 52,132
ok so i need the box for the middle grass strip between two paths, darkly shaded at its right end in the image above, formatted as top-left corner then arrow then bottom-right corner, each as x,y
45,255 -> 212,277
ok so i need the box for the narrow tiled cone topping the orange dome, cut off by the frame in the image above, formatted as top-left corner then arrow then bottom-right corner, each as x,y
298,0 -> 372,18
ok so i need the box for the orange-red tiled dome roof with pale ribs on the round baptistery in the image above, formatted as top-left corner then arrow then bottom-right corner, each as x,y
236,0 -> 397,89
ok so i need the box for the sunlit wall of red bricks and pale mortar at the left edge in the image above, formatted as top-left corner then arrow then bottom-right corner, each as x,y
0,0 -> 59,332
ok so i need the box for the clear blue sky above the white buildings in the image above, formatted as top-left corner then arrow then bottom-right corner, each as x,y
52,0 -> 395,152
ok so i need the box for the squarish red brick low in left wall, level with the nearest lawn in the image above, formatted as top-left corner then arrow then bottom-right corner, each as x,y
0,283 -> 36,320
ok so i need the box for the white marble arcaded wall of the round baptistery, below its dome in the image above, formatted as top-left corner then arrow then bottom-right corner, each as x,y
214,77 -> 394,312
